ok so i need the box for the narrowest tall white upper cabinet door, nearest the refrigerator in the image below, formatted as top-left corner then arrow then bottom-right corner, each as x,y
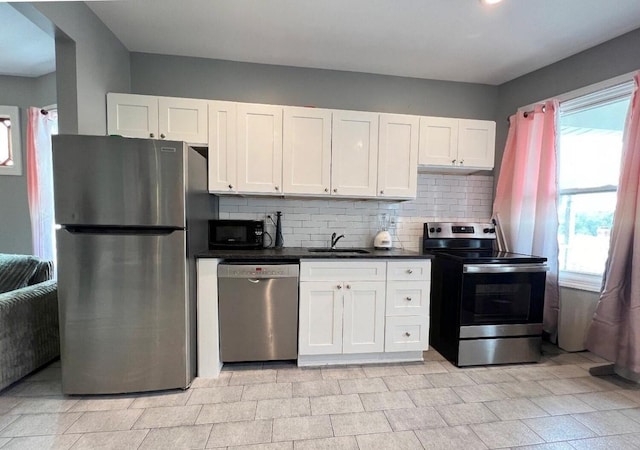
207,102 -> 238,192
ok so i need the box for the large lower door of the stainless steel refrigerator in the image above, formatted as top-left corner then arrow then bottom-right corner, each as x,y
57,229 -> 190,394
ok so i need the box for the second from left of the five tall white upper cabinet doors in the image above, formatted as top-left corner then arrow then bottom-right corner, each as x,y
238,103 -> 282,194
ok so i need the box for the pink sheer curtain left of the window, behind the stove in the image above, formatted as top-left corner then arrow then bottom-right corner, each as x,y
493,101 -> 559,342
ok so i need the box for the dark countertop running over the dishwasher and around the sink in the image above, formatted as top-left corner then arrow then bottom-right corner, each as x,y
196,247 -> 433,261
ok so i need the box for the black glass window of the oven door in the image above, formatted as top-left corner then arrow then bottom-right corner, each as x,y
460,273 -> 545,325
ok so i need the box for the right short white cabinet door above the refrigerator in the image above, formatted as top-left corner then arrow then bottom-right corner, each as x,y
158,97 -> 209,145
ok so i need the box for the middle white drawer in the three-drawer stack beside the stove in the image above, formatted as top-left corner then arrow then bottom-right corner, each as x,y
386,281 -> 430,316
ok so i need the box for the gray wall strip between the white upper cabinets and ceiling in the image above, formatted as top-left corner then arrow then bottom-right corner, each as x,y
131,53 -> 498,120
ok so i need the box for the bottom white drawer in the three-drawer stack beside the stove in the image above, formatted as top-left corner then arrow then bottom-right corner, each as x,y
384,316 -> 429,352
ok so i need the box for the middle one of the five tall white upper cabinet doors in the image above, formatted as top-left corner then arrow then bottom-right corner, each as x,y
282,107 -> 331,195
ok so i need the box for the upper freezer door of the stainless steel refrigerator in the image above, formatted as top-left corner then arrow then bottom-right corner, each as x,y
52,135 -> 187,228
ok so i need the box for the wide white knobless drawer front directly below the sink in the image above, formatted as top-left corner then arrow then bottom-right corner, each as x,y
300,260 -> 387,281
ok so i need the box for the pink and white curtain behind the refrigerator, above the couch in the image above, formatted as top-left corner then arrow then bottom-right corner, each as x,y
27,107 -> 57,261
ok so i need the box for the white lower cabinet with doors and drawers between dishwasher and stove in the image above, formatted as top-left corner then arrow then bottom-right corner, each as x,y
298,259 -> 431,365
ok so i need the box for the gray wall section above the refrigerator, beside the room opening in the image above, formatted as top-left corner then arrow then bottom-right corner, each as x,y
32,2 -> 130,135
